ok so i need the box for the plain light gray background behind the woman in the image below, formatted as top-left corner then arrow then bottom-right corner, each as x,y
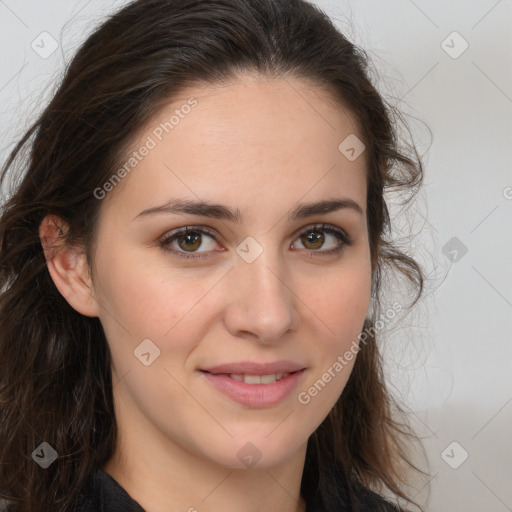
0,0 -> 512,512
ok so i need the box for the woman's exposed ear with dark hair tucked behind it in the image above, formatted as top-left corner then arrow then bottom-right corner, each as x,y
39,215 -> 99,317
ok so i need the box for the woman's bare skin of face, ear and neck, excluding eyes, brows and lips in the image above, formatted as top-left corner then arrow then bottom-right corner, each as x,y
40,75 -> 371,512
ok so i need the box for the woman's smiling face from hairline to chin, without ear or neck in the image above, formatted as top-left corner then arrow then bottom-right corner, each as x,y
88,76 -> 371,467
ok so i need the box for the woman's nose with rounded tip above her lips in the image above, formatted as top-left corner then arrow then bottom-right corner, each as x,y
225,245 -> 300,344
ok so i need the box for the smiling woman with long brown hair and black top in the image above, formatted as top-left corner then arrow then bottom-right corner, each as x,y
0,0 -> 423,512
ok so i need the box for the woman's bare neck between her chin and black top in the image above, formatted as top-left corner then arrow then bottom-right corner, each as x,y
102,394 -> 307,512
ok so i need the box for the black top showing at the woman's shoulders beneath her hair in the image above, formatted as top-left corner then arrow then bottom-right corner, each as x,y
76,469 -> 399,512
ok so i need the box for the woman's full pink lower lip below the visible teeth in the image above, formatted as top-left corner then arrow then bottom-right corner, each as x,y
202,370 -> 305,407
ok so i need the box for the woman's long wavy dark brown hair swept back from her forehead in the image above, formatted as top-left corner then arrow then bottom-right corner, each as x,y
0,0 -> 423,512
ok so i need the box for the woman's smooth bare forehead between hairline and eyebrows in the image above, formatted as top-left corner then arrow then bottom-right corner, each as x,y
101,76 -> 366,218
